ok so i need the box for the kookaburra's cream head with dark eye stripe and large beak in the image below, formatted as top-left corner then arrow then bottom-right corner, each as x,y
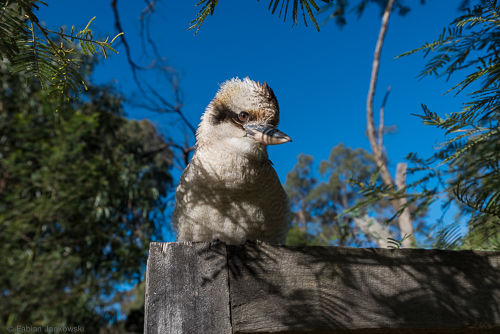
197,78 -> 291,156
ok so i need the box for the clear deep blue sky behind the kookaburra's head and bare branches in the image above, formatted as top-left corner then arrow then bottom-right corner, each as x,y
39,0 -> 468,240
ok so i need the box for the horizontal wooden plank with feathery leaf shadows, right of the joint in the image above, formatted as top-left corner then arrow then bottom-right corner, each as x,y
227,242 -> 500,333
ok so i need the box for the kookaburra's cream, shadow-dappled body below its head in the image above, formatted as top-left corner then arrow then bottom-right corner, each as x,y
173,153 -> 288,244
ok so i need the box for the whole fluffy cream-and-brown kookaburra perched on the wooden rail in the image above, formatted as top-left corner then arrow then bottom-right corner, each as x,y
172,78 -> 291,244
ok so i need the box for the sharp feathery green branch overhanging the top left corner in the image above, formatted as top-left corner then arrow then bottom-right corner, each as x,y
0,0 -> 121,99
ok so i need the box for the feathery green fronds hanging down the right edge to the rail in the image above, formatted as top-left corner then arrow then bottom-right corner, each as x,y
336,1 -> 500,249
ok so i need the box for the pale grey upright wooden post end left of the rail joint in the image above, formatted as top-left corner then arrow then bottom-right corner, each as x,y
144,242 -> 232,334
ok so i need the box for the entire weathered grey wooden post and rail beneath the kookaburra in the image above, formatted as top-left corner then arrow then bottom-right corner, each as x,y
144,242 -> 500,334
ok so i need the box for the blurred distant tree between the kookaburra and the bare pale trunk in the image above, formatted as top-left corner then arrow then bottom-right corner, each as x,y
285,144 -> 426,247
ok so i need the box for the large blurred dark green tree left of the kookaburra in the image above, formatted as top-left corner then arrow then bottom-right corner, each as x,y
0,61 -> 172,333
